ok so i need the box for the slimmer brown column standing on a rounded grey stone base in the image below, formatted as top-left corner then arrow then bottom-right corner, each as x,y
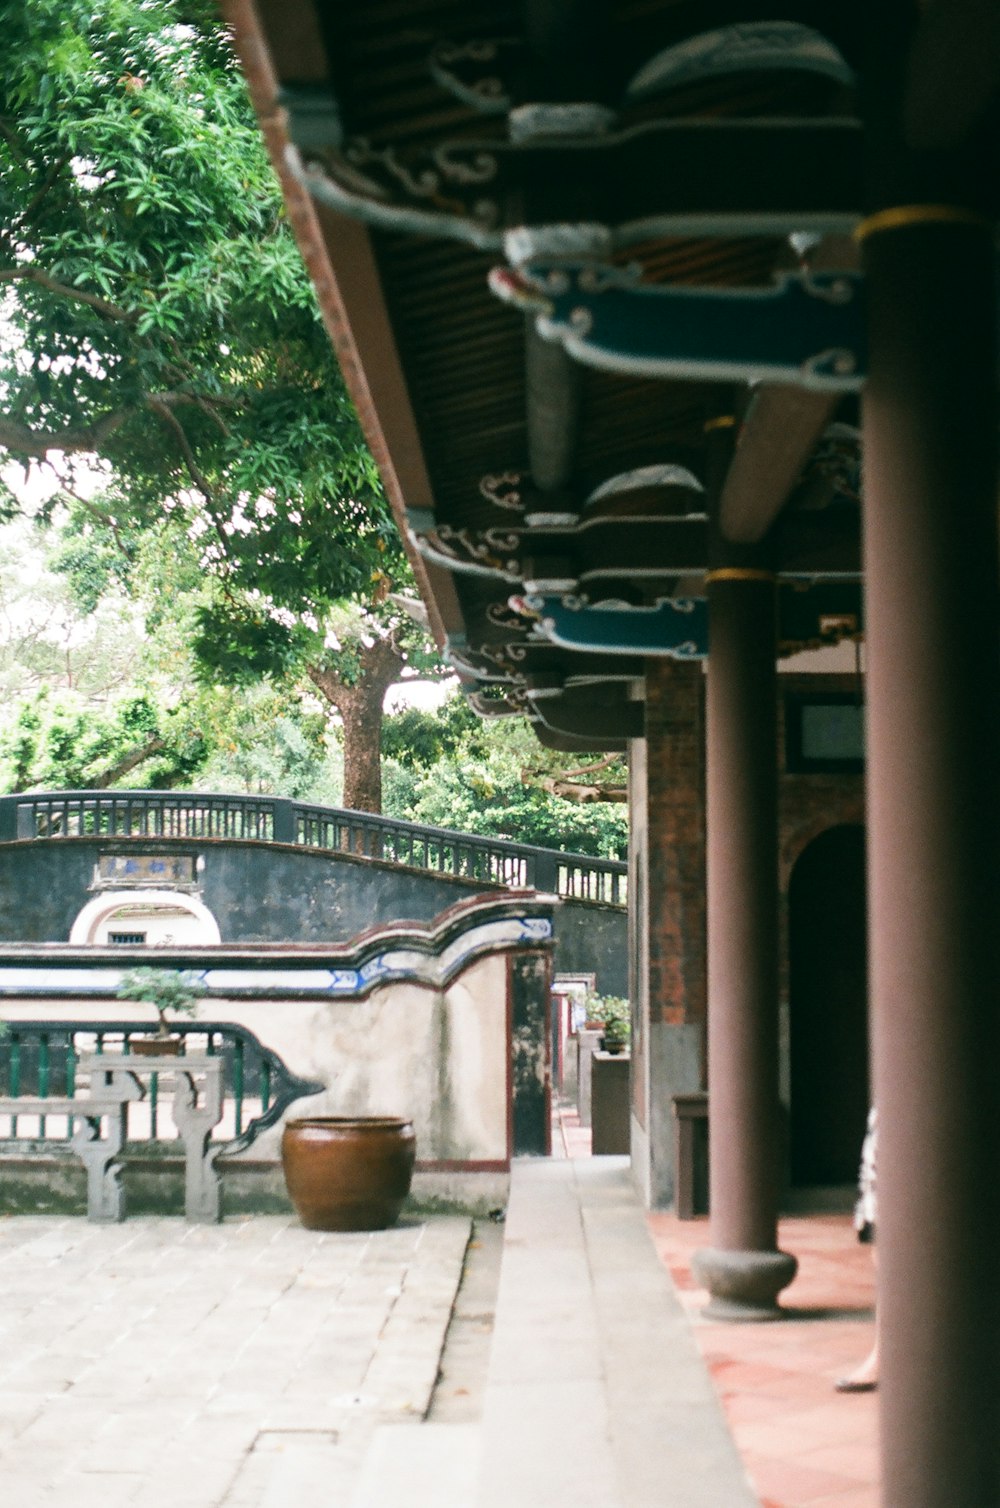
695,566 -> 796,1320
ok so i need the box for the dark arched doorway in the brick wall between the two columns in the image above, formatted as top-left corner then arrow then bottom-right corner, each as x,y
789,826 -> 869,1188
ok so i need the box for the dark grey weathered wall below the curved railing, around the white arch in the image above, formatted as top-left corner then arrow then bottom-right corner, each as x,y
0,838 -> 627,995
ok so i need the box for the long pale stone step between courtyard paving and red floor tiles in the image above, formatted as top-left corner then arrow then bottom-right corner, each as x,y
472,1157 -> 757,1508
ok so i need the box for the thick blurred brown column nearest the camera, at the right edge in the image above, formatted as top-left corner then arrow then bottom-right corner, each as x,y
863,204 -> 1000,1508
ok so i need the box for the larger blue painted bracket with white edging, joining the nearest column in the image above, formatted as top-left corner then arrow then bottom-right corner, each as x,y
490,262 -> 866,392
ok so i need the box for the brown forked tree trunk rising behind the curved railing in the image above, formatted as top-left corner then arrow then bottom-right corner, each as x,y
308,639 -> 404,816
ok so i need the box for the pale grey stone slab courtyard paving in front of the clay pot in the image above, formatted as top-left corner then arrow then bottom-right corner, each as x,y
0,1215 -> 471,1508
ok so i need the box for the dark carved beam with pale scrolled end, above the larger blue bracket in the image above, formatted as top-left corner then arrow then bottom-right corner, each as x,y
287,117 -> 863,258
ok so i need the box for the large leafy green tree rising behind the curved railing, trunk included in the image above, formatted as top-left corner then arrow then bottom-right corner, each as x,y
0,0 -> 437,810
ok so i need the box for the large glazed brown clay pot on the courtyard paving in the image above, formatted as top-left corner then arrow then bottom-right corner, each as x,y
281,1116 -> 416,1231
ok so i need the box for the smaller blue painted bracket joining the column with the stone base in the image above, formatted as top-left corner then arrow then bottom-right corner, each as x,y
526,597 -> 709,659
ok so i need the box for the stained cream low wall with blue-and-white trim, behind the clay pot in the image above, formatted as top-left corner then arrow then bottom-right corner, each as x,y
0,891 -> 552,1172
